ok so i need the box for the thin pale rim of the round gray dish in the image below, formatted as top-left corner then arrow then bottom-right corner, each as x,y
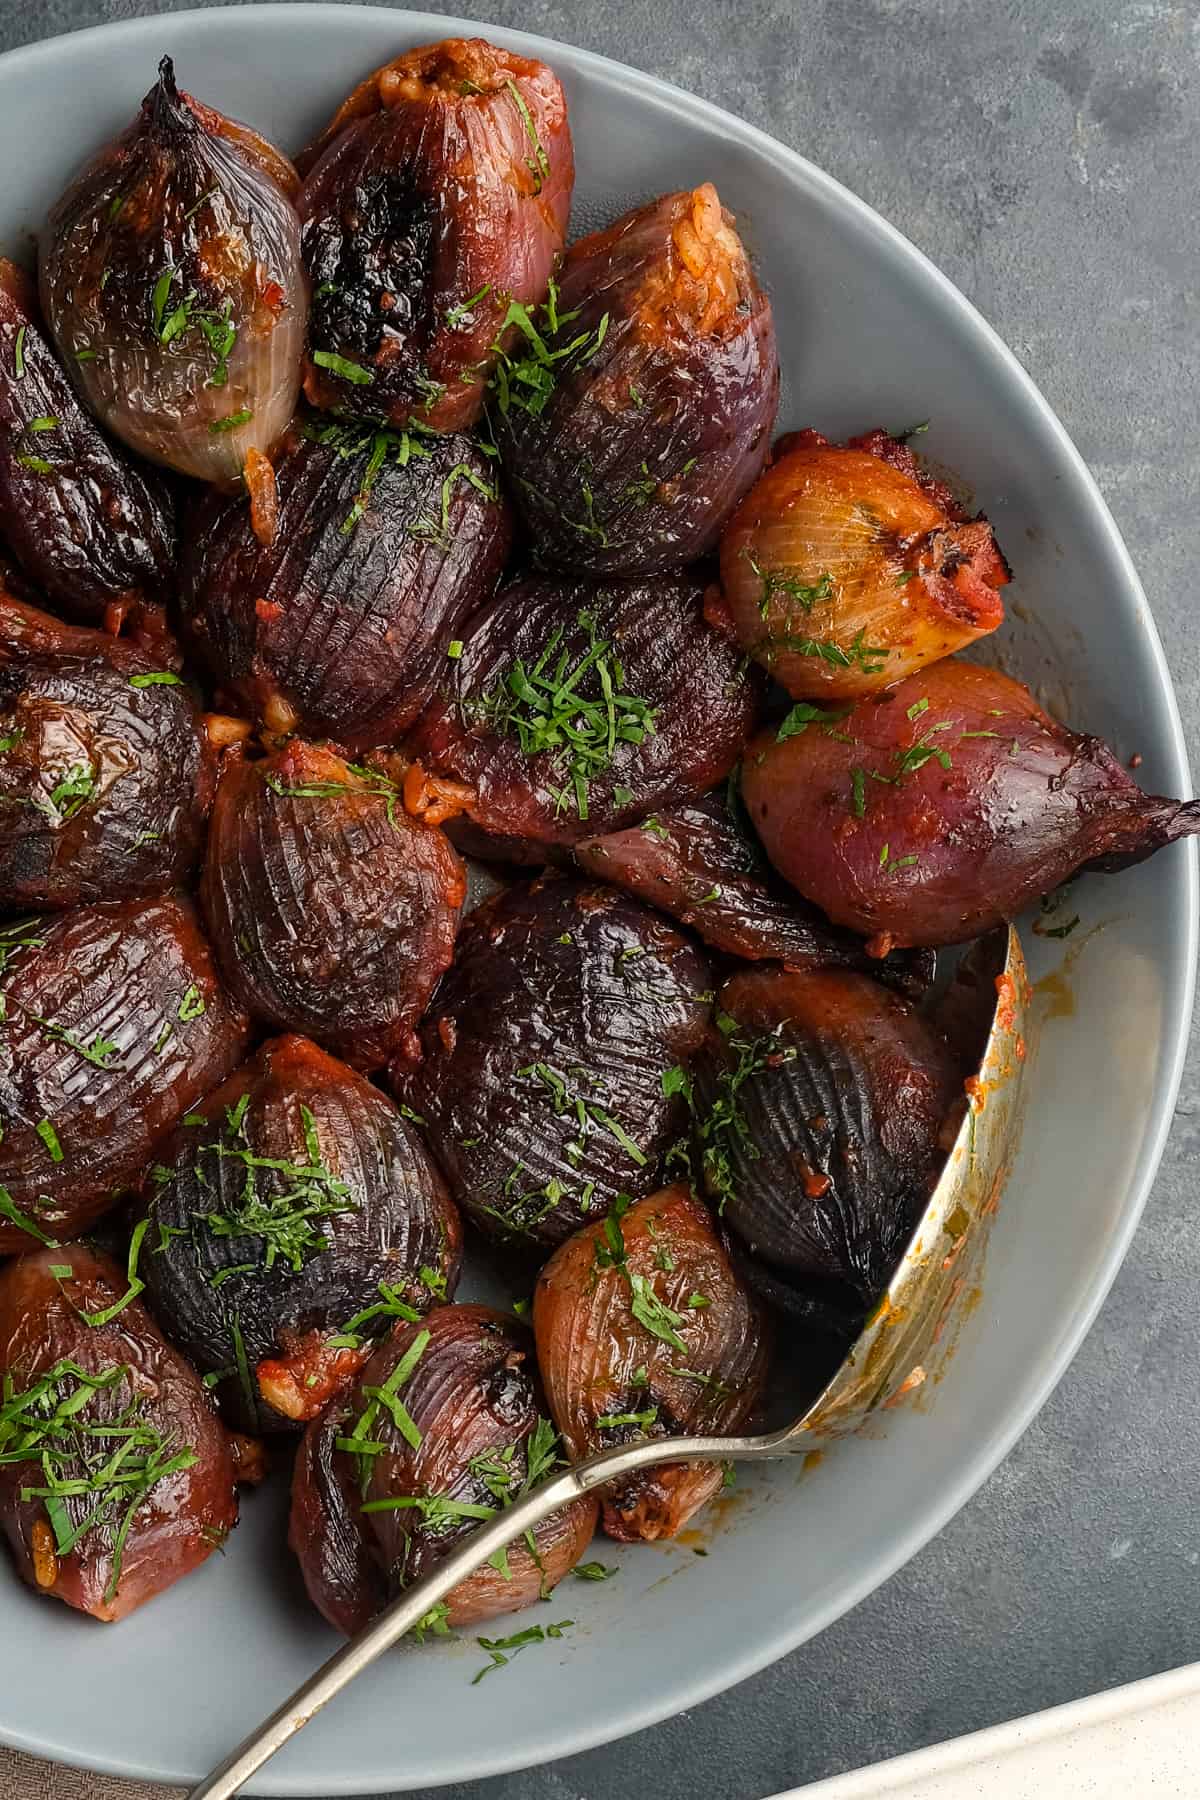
0,0 -> 1200,1796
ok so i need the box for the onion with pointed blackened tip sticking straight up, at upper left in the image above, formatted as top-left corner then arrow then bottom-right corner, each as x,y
40,56 -> 308,486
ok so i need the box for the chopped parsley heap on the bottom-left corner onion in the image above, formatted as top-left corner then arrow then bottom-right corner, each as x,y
0,1357 -> 200,1602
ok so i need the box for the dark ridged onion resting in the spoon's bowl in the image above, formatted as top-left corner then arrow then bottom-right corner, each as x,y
694,968 -> 963,1310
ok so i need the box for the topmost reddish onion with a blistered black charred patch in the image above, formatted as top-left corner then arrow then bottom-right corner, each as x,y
299,38 -> 574,432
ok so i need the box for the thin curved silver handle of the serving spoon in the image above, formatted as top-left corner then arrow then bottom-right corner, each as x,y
187,1438 -> 752,1800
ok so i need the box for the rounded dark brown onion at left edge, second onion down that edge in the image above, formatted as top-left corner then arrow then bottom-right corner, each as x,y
0,581 -> 214,911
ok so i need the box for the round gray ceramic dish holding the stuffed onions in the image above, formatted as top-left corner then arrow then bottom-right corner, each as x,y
0,5 -> 1196,1795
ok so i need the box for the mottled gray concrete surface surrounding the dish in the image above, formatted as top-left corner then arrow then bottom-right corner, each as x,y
0,0 -> 1200,1800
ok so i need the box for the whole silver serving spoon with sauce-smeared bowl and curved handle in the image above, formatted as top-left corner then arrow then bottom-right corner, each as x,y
187,925 -> 1029,1800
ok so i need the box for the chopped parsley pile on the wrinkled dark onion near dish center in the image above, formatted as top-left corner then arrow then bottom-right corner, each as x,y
477,612 -> 658,819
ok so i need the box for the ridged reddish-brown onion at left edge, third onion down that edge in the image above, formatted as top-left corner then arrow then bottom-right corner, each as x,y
0,896 -> 248,1255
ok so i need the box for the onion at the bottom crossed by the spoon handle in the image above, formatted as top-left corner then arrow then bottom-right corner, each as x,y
290,1307 -> 597,1636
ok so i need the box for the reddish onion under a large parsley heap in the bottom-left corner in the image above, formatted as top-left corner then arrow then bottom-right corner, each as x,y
0,1244 -> 237,1620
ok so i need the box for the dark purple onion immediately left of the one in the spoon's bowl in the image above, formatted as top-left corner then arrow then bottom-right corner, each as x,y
392,878 -> 711,1244
